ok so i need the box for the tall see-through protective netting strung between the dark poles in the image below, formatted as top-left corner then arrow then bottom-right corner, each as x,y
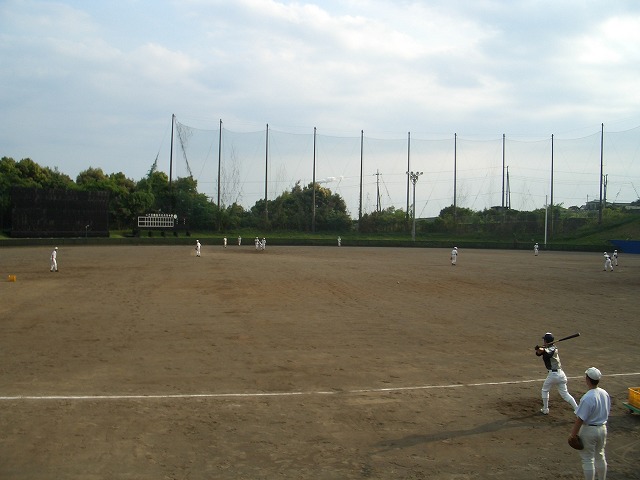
173,120 -> 640,218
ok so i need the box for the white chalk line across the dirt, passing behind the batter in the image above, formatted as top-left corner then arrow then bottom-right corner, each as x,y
0,372 -> 640,401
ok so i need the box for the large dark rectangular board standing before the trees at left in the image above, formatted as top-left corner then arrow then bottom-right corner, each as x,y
11,187 -> 109,238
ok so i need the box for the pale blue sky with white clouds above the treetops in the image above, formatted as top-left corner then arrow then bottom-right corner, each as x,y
0,0 -> 640,216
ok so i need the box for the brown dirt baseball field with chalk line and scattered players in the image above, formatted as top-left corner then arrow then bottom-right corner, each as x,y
0,246 -> 640,480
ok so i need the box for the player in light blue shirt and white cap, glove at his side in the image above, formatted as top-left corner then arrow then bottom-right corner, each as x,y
569,367 -> 611,480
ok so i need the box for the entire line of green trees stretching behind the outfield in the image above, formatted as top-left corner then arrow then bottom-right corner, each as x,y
0,157 -> 640,238
